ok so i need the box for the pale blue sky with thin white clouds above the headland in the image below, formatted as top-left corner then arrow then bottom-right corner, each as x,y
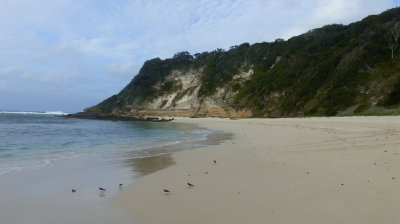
0,0 -> 400,112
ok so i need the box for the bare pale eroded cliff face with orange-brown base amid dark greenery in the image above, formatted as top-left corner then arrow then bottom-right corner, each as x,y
113,69 -> 253,118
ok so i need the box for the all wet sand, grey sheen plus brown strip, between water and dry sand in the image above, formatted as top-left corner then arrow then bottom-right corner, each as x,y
0,121 -> 222,224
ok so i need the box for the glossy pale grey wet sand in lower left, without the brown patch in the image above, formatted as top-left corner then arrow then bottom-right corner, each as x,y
0,158 -> 134,224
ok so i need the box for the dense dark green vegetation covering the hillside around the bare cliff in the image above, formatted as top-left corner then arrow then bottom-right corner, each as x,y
88,8 -> 400,116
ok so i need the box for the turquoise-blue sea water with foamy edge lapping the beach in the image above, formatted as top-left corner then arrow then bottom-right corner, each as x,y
0,112 -> 211,175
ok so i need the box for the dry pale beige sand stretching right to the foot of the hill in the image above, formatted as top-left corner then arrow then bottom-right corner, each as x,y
111,117 -> 400,224
